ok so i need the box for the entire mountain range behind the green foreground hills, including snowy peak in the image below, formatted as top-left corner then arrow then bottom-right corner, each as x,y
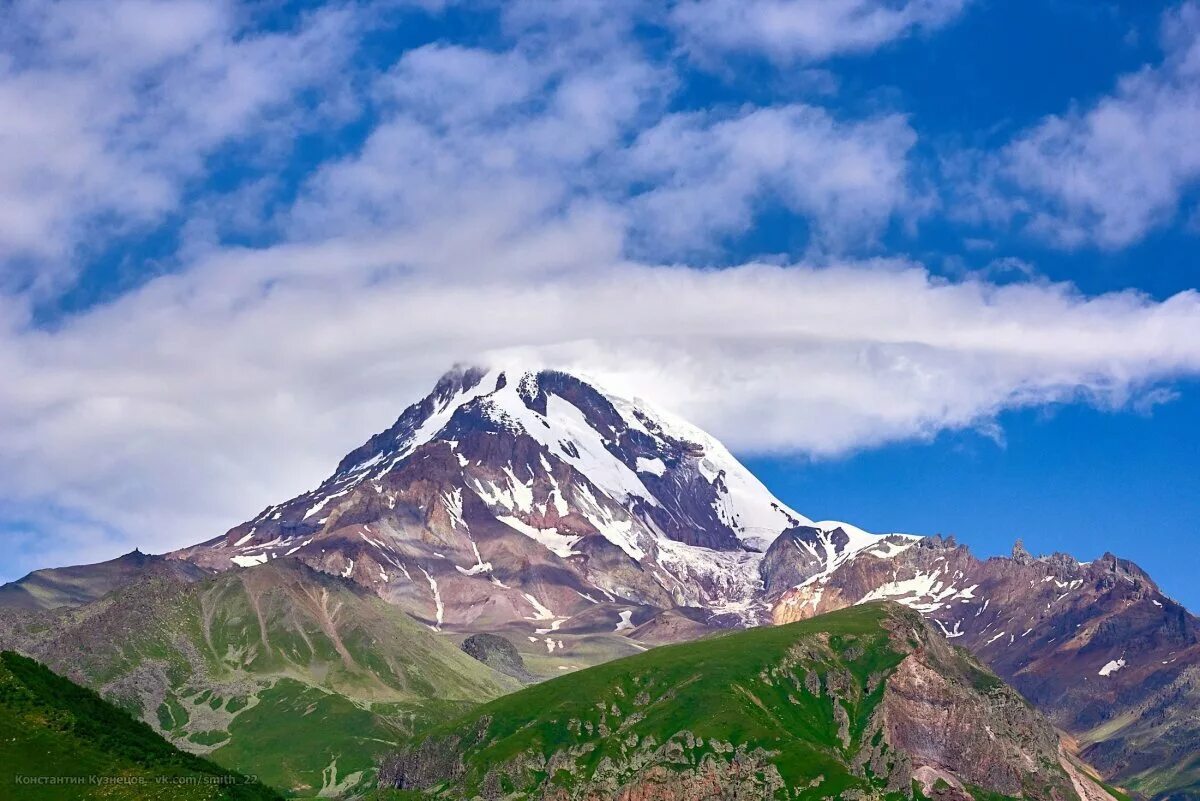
0,368 -> 1200,797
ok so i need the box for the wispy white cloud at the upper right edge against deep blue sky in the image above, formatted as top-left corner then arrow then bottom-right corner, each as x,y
982,2 -> 1200,248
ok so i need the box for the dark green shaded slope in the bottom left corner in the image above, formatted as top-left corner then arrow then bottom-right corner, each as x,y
0,651 -> 280,801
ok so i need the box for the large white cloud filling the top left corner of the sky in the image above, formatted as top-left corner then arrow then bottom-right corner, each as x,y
0,0 -> 349,293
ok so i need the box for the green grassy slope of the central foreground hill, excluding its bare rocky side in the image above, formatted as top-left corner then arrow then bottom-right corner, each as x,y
384,606 -> 936,797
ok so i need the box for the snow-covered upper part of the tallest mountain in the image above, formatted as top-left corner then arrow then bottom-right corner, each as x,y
326,368 -> 809,549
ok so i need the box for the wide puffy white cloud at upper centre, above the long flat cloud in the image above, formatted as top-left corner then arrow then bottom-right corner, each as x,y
292,41 -> 907,257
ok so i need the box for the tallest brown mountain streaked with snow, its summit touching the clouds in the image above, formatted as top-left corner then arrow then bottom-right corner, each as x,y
173,368 -> 830,632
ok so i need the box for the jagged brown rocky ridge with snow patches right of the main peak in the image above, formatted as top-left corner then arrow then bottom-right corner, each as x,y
768,537 -> 1200,797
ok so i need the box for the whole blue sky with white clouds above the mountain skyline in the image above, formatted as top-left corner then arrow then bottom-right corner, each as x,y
0,0 -> 1200,608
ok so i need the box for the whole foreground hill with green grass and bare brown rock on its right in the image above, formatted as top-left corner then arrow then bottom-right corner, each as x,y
379,603 -> 1114,801
